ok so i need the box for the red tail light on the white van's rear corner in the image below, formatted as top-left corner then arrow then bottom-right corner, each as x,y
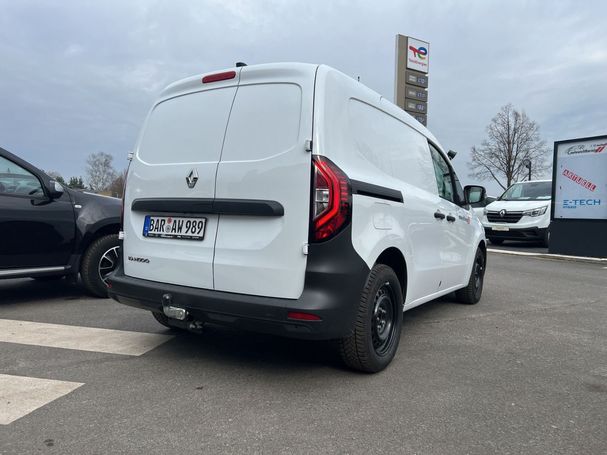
310,155 -> 352,242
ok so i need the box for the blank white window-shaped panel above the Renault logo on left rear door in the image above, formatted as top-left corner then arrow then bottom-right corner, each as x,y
138,87 -> 236,164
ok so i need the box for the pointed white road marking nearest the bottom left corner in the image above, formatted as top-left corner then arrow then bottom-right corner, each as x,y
0,374 -> 83,425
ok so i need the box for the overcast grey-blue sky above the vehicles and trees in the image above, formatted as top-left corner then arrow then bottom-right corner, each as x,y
0,0 -> 607,193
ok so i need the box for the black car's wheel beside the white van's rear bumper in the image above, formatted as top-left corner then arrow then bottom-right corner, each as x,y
80,234 -> 120,297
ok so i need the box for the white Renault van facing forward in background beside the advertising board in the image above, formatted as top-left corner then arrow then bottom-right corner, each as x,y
483,180 -> 552,246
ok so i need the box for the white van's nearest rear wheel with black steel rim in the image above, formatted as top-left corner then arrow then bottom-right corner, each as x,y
338,264 -> 403,373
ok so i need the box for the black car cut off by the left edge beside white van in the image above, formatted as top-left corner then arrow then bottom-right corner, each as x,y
0,144 -> 121,297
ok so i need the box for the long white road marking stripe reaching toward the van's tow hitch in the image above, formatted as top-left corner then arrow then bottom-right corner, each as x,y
0,319 -> 173,356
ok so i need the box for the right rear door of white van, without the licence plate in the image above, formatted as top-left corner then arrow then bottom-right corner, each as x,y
214,64 -> 317,299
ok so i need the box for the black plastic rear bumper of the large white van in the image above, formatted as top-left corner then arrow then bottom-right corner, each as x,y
108,229 -> 369,340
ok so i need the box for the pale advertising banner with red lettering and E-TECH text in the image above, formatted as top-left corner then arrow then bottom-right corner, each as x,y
553,136 -> 607,220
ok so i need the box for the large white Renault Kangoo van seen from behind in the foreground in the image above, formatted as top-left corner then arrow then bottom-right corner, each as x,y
108,63 -> 486,372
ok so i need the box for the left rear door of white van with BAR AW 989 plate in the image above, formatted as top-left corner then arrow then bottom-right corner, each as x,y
124,72 -> 238,289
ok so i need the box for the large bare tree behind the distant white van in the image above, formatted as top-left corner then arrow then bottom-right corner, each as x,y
468,104 -> 550,189
